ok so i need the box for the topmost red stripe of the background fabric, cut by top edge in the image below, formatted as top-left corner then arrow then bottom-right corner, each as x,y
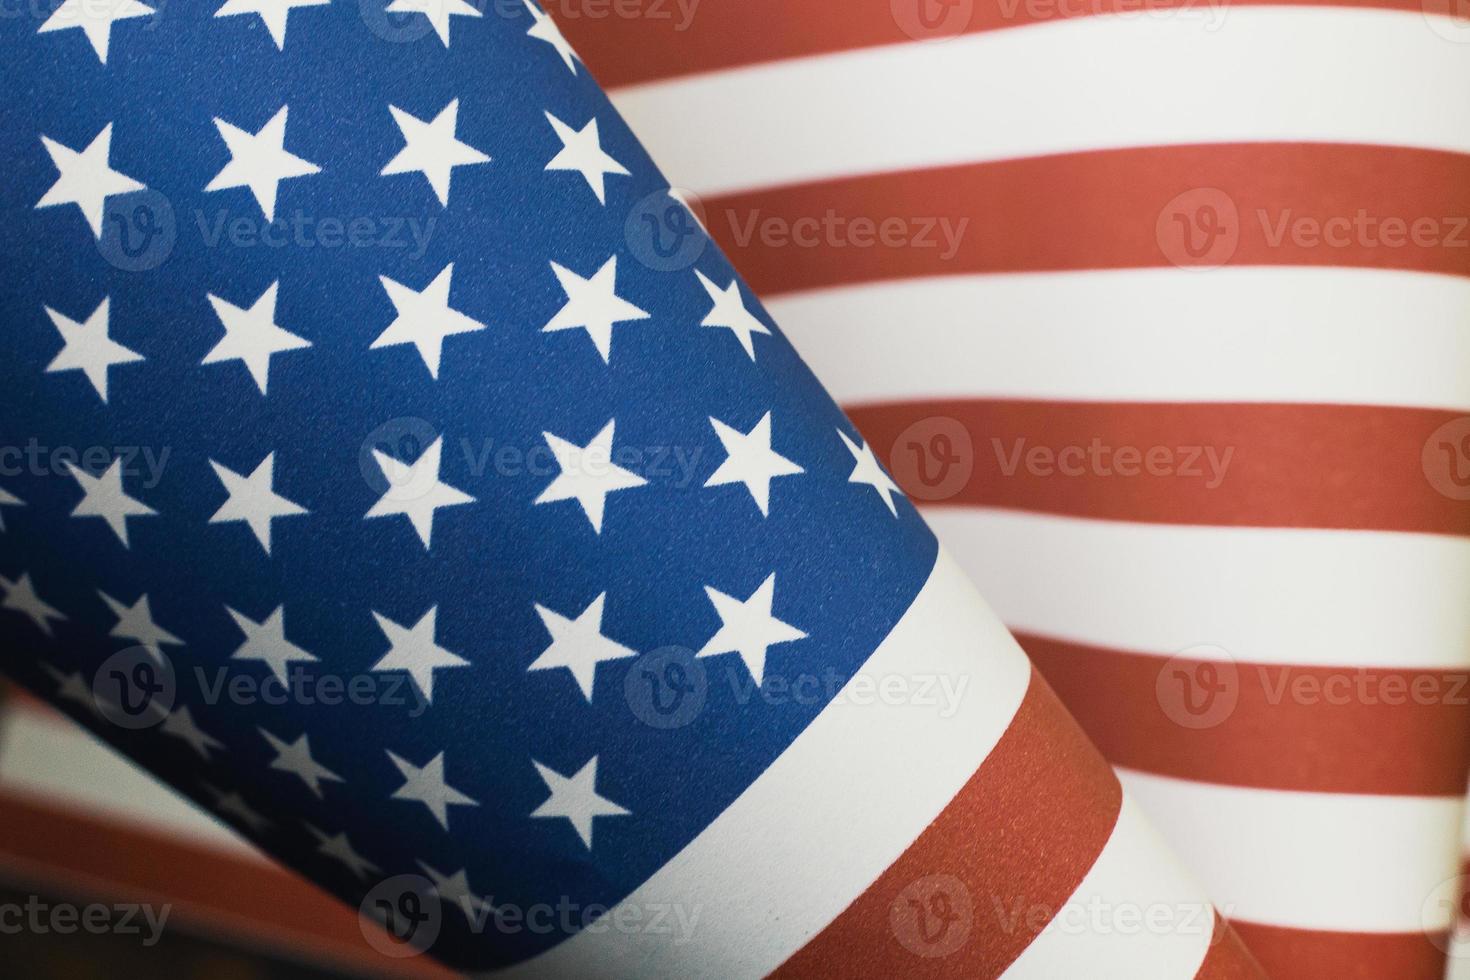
544,0 -> 1421,87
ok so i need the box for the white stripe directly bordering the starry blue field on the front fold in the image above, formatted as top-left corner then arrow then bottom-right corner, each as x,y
515,552 -> 1030,977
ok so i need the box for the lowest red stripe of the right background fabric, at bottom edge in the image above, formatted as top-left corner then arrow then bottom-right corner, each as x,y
1232,922 -> 1448,980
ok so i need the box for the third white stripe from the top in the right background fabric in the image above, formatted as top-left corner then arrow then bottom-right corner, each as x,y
926,511 -> 1470,667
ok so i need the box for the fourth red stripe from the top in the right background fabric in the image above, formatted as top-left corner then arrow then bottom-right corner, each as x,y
1017,633 -> 1470,796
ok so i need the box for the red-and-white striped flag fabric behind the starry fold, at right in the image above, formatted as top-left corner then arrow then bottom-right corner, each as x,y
546,0 -> 1470,980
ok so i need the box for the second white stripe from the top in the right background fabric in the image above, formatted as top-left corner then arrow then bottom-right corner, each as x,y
766,268 -> 1470,411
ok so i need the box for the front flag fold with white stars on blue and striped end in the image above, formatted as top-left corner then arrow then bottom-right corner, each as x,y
0,0 -> 1260,977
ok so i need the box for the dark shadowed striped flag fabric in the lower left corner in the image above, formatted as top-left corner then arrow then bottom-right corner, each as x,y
0,693 -> 457,980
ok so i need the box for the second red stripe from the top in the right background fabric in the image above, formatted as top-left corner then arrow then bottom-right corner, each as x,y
703,143 -> 1470,297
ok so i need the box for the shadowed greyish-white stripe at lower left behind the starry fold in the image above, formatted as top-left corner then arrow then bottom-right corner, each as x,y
0,702 -> 269,861
